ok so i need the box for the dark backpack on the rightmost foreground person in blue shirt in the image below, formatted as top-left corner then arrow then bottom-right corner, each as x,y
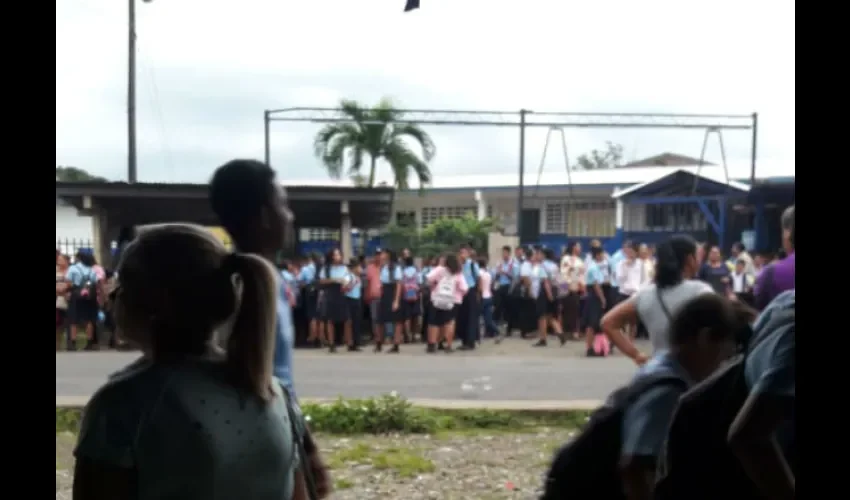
655,309 -> 794,500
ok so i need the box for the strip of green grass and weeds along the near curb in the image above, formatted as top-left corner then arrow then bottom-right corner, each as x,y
56,394 -> 589,434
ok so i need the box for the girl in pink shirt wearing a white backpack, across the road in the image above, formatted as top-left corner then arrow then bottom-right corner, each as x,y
426,253 -> 469,354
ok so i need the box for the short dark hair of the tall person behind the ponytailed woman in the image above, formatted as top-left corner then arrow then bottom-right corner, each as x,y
209,160 -> 275,240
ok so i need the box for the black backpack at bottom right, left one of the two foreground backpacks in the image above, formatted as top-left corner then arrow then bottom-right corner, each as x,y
540,373 -> 687,500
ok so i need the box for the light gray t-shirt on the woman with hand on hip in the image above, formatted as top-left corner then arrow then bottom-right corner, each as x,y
629,280 -> 714,352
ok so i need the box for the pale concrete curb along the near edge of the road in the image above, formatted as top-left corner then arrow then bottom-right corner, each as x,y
56,396 -> 602,411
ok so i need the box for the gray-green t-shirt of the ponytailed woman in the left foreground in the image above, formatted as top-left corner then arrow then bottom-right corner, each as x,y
75,358 -> 298,500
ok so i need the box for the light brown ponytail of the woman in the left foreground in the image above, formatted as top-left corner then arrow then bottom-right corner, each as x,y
224,253 -> 278,402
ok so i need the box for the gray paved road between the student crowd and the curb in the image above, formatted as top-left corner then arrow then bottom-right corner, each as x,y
56,338 -> 635,401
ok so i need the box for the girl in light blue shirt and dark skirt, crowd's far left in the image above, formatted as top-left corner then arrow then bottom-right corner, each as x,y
65,250 -> 99,351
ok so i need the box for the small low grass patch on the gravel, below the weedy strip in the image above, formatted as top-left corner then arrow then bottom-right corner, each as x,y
327,443 -> 436,478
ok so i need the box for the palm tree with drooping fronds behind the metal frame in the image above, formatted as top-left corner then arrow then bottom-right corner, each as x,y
313,98 -> 436,189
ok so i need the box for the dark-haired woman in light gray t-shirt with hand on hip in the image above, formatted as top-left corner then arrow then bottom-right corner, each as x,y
601,235 -> 714,364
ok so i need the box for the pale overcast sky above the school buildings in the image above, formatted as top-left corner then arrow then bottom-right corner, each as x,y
56,0 -> 795,184
